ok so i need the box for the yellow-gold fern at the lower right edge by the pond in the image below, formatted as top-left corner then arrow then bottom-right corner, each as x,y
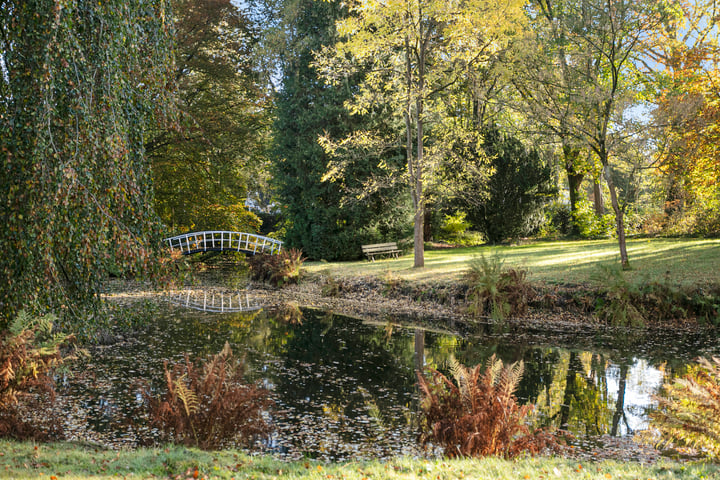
650,357 -> 720,459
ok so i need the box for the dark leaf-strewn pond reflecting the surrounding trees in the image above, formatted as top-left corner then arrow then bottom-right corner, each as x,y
59,290 -> 720,460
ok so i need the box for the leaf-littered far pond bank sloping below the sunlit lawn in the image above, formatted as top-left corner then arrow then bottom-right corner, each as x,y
250,276 -> 720,332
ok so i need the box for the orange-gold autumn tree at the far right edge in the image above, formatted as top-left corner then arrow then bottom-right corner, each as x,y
643,0 -> 720,233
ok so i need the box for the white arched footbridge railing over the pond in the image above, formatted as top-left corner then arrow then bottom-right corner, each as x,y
165,230 -> 283,255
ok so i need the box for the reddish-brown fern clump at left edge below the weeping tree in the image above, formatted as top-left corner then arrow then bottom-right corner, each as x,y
0,311 -> 74,440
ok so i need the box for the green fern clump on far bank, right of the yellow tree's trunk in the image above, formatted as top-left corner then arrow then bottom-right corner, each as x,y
465,255 -> 533,320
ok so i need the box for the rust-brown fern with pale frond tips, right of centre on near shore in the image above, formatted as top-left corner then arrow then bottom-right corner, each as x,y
418,355 -> 555,458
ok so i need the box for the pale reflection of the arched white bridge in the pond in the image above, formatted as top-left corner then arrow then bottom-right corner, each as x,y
166,288 -> 262,313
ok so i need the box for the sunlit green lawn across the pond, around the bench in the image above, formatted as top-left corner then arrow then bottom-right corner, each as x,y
304,238 -> 720,286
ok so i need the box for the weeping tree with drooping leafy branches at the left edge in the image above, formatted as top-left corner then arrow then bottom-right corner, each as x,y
0,0 -> 173,328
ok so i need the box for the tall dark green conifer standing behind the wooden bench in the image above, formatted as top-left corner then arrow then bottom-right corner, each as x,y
273,0 -> 406,259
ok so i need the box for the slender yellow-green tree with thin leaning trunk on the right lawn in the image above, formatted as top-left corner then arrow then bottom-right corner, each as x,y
516,0 -> 665,268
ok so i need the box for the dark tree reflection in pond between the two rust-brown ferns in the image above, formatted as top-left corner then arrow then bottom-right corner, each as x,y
268,311 -> 423,458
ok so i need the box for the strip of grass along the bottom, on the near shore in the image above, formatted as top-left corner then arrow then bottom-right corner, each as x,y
0,441 -> 720,480
